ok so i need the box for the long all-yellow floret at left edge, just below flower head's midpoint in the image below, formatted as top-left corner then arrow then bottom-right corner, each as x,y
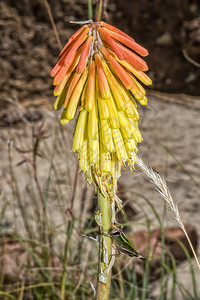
72,109 -> 88,152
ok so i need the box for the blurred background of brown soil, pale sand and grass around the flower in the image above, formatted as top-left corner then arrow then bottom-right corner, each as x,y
0,0 -> 200,300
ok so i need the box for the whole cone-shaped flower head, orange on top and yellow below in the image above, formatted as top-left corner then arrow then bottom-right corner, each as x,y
51,21 -> 152,194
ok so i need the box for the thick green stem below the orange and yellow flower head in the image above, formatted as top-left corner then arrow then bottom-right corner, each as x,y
96,190 -> 112,300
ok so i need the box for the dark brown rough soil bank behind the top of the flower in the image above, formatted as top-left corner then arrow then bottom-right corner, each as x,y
0,0 -> 200,107
